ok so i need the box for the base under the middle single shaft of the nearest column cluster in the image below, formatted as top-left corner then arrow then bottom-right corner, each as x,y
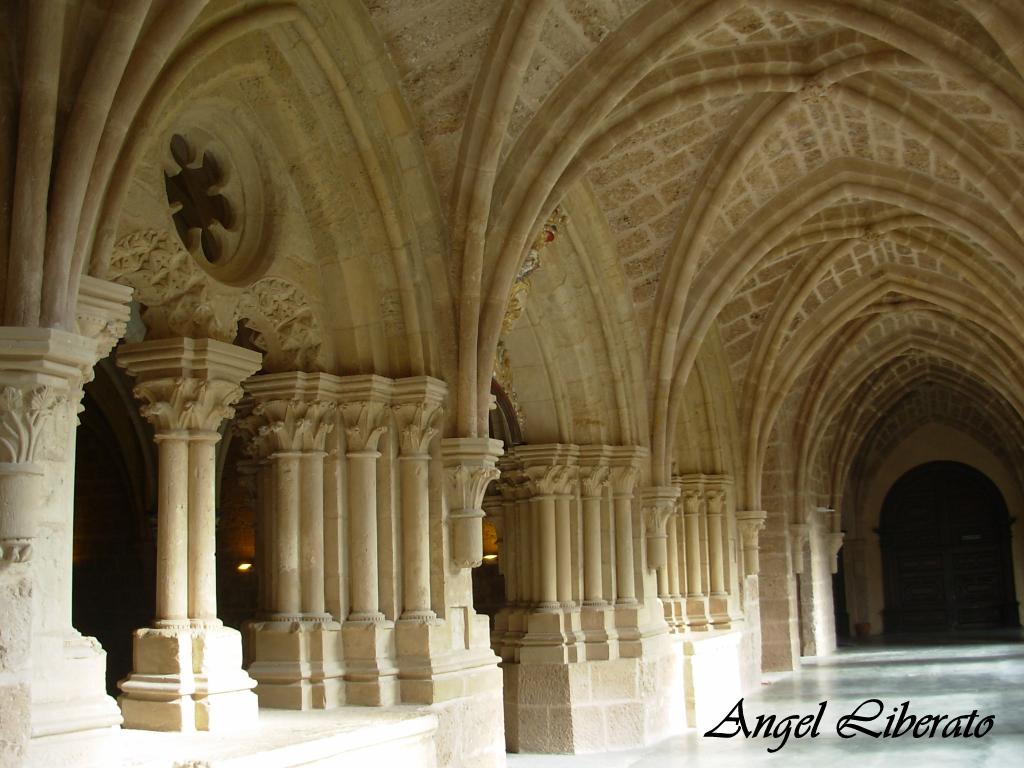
341,621 -> 398,707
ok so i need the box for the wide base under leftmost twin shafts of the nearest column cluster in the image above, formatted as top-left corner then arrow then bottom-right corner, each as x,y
247,621 -> 345,710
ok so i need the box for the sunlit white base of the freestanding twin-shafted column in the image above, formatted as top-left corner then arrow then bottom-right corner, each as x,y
118,627 -> 258,731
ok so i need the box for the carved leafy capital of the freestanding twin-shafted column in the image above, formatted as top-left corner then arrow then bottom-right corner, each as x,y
118,338 -> 260,433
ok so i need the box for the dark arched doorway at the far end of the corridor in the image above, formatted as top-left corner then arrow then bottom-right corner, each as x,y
879,462 -> 1018,632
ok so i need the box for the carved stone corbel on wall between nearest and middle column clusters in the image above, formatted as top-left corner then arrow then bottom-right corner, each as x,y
441,437 -> 502,568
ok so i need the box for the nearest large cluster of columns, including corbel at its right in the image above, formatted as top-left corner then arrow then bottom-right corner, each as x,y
242,372 -> 501,709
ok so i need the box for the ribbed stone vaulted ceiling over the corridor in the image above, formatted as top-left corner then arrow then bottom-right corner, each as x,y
369,0 -> 1024,503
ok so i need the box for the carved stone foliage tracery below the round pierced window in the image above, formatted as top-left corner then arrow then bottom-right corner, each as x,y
108,229 -> 324,372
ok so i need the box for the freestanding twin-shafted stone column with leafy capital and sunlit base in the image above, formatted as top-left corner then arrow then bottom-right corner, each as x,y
118,338 -> 260,730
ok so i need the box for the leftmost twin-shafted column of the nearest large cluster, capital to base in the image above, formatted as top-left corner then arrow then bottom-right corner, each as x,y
245,372 -> 344,710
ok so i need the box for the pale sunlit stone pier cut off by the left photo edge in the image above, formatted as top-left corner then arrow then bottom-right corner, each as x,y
0,328 -> 97,765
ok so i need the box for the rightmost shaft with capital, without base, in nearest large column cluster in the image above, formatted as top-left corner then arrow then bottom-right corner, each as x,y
391,376 -> 447,622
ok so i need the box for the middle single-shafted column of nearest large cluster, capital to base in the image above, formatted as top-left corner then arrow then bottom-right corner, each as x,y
341,375 -> 398,706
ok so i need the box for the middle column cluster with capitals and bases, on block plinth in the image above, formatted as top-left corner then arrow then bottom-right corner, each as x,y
485,444 -> 643,664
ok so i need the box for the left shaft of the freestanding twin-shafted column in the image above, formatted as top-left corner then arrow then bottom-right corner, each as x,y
157,434 -> 188,625
